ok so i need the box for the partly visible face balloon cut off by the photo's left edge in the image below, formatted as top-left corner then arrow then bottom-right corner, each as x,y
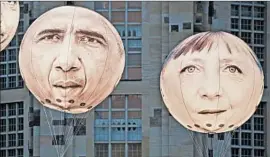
0,1 -> 20,51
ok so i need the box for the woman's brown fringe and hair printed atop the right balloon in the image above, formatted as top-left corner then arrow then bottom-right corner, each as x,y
167,31 -> 262,71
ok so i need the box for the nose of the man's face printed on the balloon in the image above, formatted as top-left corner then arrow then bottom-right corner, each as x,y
55,44 -> 81,72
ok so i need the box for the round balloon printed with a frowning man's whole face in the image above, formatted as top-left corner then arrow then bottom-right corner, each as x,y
19,6 -> 125,114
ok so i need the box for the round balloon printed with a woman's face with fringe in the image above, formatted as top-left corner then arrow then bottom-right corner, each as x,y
160,32 -> 264,133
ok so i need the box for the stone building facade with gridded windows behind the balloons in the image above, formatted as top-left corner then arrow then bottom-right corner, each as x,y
0,1 -> 270,157
